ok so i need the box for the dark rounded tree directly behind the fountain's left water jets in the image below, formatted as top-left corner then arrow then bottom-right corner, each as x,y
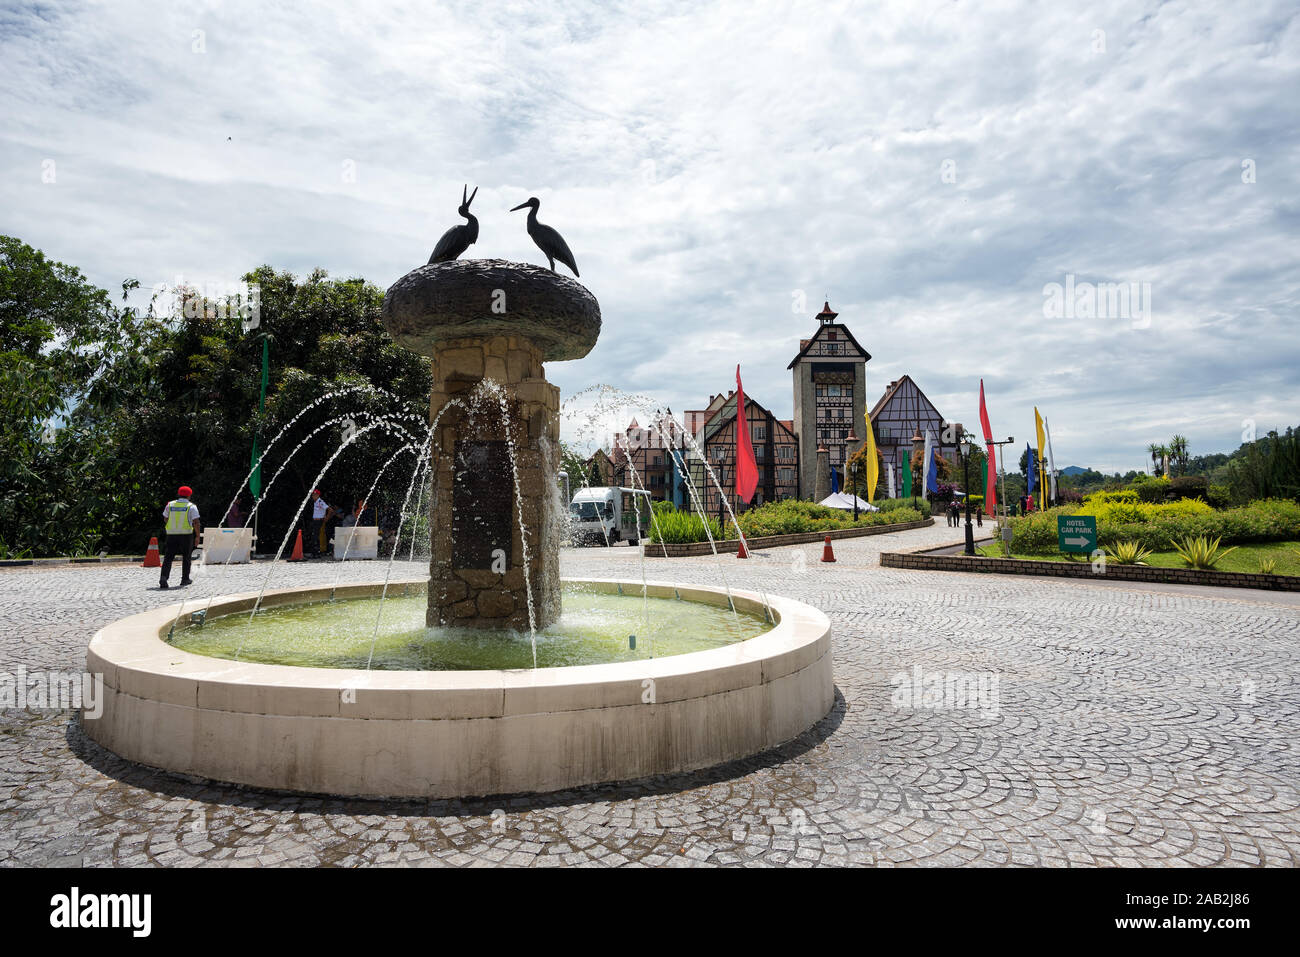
110,265 -> 432,551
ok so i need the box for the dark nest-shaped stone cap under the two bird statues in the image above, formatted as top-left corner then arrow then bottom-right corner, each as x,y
384,259 -> 601,361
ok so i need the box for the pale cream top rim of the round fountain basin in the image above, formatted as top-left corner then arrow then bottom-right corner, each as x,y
86,579 -> 831,719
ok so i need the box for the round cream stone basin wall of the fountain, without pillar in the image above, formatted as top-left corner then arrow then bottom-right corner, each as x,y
82,580 -> 833,798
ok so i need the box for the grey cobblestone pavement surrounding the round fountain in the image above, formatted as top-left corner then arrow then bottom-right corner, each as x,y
0,525 -> 1300,866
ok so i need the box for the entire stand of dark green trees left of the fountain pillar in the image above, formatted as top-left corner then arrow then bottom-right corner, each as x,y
0,237 -> 432,555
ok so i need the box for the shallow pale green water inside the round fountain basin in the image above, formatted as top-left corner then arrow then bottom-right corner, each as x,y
172,586 -> 771,671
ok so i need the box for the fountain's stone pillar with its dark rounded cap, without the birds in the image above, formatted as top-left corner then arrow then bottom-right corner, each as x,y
384,260 -> 601,628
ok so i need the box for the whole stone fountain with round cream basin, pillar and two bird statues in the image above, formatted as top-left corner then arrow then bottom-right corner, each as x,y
82,210 -> 835,798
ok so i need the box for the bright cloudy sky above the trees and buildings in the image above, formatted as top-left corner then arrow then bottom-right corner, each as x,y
0,0 -> 1300,471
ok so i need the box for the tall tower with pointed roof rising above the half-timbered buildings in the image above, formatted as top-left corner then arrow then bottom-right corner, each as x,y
787,302 -> 871,498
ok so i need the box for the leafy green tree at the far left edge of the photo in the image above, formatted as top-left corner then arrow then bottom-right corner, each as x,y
0,237 -> 163,555
